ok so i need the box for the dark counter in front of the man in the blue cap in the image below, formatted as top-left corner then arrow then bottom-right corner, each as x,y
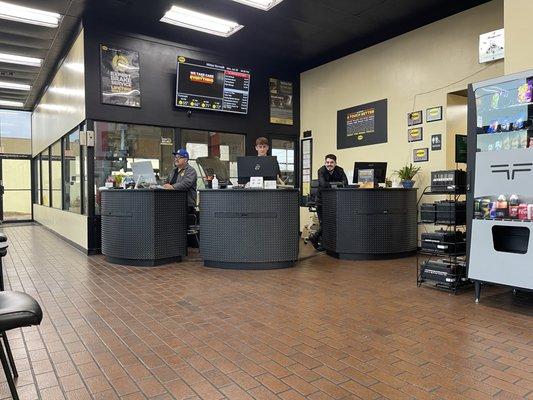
101,189 -> 187,266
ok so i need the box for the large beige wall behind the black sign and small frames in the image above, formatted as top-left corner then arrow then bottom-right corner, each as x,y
300,0 -> 504,228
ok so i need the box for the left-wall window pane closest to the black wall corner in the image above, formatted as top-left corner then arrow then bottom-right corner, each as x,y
63,130 -> 81,214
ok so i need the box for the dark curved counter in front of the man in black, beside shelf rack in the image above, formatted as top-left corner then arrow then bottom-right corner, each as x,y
322,188 -> 418,260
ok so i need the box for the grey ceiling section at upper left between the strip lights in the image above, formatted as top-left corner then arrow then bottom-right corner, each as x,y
0,0 -> 86,110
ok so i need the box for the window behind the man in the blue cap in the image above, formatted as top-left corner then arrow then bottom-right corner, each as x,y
94,122 -> 174,214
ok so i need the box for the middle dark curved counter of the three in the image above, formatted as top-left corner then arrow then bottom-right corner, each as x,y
200,189 -> 299,269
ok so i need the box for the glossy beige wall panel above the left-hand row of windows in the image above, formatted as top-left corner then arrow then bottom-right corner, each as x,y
32,31 -> 85,156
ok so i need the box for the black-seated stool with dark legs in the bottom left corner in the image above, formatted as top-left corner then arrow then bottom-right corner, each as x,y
0,291 -> 43,400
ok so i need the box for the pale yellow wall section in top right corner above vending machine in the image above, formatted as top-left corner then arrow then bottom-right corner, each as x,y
504,0 -> 533,74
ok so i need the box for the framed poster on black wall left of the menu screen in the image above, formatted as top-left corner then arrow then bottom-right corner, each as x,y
100,45 -> 141,107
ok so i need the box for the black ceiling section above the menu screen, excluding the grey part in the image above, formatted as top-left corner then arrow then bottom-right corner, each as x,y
89,0 -> 488,72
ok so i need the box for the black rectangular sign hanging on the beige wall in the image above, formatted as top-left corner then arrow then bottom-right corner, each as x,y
337,99 -> 387,149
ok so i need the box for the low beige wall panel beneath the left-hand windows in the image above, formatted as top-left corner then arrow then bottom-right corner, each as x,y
33,204 -> 88,250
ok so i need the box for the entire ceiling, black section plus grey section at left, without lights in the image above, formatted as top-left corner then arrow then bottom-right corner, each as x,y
0,0 -> 489,110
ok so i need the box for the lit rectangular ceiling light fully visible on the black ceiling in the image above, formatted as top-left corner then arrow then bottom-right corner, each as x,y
160,6 -> 243,37
